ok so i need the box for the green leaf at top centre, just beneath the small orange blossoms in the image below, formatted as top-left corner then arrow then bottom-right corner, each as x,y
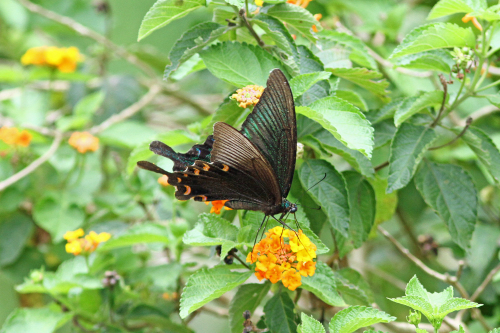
267,3 -> 322,42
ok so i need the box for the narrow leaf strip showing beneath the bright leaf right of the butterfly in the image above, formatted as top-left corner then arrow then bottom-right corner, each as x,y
310,129 -> 375,177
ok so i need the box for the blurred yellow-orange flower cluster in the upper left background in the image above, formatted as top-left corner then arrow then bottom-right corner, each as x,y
21,46 -> 83,73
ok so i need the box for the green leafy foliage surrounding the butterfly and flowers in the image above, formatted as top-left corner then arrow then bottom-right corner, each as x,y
0,0 -> 500,333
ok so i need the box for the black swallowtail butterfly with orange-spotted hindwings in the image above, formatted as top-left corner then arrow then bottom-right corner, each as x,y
137,69 -> 297,220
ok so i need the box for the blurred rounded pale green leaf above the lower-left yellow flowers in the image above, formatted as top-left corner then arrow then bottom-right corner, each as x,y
33,193 -> 85,242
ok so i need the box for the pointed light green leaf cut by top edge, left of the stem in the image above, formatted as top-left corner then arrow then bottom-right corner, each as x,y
137,0 -> 205,41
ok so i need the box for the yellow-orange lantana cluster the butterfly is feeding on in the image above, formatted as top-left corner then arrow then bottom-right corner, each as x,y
247,227 -> 316,291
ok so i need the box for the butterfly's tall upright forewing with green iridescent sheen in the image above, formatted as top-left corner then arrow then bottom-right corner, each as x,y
241,69 -> 297,198
